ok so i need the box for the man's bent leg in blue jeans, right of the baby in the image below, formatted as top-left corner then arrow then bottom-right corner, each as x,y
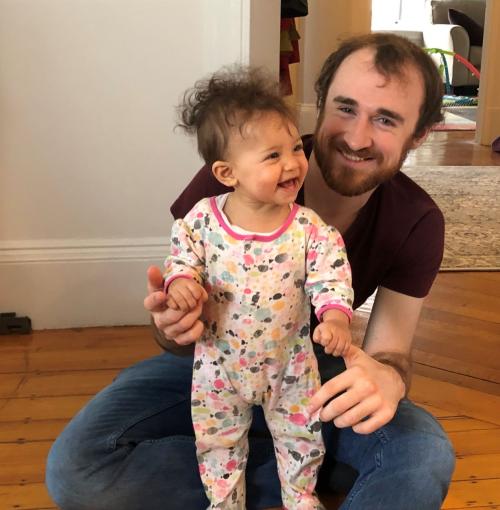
322,400 -> 455,510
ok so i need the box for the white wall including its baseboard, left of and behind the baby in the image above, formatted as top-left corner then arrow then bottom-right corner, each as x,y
0,0 -> 279,329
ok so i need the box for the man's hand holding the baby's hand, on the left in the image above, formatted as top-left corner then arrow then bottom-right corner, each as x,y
144,266 -> 208,345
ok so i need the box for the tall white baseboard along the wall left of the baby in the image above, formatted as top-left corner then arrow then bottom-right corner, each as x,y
0,238 -> 168,329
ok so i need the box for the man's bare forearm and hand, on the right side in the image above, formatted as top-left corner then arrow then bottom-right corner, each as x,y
309,287 -> 423,434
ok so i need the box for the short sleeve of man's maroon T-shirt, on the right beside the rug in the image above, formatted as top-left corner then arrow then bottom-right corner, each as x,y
380,207 -> 444,298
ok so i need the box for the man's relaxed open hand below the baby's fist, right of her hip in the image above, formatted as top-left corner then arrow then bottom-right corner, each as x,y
308,345 -> 405,434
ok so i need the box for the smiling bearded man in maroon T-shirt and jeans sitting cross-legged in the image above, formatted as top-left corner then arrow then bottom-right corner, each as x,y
47,34 -> 454,510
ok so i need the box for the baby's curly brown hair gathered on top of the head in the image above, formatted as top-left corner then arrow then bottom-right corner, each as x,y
177,65 -> 295,165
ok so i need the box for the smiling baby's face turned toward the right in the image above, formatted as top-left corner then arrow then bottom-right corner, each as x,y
227,113 -> 308,205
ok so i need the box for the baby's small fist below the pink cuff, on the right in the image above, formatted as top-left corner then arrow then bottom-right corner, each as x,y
313,308 -> 352,356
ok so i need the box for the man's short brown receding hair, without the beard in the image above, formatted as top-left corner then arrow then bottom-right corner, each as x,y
315,33 -> 444,138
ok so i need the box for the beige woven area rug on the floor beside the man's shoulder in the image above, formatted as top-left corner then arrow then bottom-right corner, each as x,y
403,166 -> 500,271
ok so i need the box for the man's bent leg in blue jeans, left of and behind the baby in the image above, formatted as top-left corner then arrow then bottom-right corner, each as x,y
46,354 -> 279,510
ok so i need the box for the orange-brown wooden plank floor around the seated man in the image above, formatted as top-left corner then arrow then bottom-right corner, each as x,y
0,132 -> 500,510
